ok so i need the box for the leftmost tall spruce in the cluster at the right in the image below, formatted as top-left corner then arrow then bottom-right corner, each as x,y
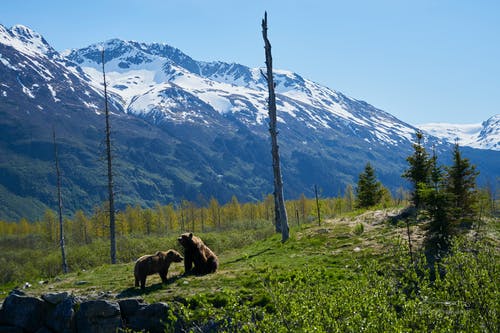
403,131 -> 431,208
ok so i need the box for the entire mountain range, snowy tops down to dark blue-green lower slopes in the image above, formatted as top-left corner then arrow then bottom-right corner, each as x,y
0,25 -> 500,219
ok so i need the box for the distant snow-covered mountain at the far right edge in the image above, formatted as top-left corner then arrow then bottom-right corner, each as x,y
417,114 -> 500,150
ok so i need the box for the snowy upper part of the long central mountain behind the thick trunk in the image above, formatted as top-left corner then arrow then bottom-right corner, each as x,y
68,39 -> 415,146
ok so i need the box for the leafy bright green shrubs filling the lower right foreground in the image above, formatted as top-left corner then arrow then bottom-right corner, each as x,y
174,235 -> 500,332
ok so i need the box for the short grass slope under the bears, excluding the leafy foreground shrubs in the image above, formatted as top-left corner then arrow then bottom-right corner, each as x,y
0,210 -> 385,302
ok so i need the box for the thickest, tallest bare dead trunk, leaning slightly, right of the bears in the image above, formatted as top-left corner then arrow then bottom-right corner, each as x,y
262,12 -> 289,242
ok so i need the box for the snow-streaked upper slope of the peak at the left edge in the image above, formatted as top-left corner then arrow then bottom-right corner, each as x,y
0,25 -> 121,112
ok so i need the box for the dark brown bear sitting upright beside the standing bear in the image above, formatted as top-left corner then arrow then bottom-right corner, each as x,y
177,233 -> 219,275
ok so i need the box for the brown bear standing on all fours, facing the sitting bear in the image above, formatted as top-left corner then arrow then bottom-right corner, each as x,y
134,250 -> 184,290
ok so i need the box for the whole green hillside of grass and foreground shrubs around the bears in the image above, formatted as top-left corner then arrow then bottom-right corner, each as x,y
0,212 -> 500,332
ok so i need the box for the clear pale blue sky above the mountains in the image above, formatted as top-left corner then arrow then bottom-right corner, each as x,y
0,0 -> 500,124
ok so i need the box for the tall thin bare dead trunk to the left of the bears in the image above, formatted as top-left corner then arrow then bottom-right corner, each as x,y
101,50 -> 116,264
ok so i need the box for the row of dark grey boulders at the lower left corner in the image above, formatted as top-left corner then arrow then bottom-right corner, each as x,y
0,289 -> 176,333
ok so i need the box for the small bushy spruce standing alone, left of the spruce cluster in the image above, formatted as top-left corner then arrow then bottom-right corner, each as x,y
356,162 -> 383,208
